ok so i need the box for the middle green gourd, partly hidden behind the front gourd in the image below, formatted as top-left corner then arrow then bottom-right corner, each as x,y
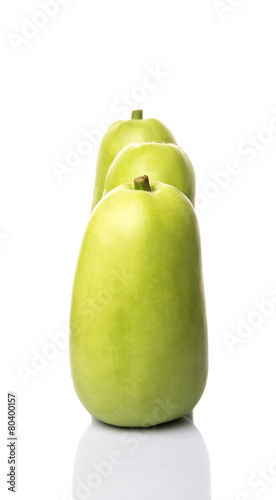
103,142 -> 195,205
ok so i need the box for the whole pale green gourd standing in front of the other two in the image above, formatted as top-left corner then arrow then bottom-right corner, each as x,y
70,176 -> 208,427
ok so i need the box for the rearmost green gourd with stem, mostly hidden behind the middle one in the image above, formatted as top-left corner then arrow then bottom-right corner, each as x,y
92,110 -> 176,210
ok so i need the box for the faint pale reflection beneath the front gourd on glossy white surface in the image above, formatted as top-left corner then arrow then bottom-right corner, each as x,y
73,417 -> 211,500
